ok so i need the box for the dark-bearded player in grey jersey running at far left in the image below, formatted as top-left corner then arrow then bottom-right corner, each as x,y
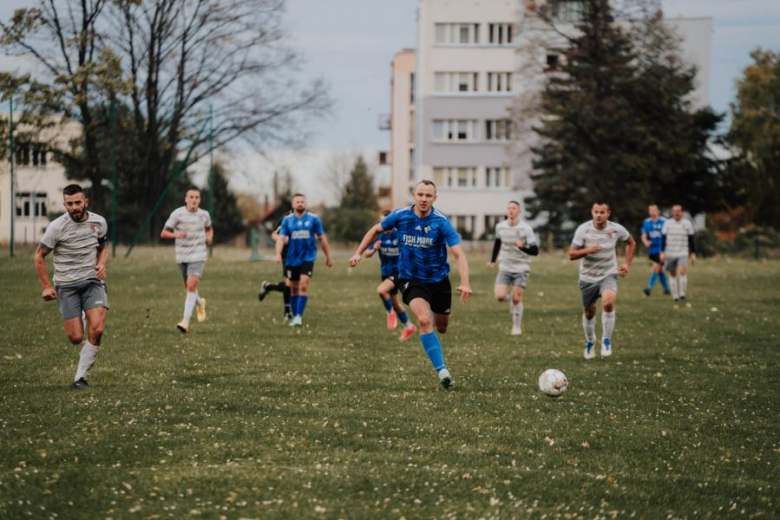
34,184 -> 108,390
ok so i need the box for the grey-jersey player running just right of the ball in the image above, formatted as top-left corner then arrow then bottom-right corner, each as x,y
569,201 -> 636,359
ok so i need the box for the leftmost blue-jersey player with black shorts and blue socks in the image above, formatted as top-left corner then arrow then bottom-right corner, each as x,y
276,193 -> 333,327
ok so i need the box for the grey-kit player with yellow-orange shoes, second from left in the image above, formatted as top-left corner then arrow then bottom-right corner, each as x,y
160,188 -> 214,333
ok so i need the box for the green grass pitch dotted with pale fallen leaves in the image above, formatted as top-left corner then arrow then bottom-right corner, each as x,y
0,248 -> 780,519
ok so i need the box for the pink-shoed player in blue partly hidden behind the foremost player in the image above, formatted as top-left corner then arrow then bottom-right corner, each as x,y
366,210 -> 417,341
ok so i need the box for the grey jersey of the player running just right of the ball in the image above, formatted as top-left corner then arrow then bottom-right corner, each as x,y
571,220 -> 631,283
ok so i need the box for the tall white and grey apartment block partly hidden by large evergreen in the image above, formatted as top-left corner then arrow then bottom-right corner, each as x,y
391,0 -> 712,239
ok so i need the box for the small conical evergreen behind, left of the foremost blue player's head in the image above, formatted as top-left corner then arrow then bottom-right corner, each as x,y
324,155 -> 379,242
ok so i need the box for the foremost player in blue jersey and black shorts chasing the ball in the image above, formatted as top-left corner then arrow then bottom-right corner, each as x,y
349,180 -> 471,388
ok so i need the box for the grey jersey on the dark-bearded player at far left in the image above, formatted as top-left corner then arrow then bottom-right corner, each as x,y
41,211 -> 108,285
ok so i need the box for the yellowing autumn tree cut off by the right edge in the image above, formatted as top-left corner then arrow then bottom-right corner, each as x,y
728,49 -> 780,229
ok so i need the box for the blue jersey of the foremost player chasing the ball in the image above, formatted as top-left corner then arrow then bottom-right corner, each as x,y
381,206 -> 460,283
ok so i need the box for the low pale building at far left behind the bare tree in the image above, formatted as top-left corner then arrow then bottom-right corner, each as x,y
0,119 -> 80,244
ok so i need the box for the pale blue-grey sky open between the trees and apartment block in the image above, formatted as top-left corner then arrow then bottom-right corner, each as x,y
0,0 -> 780,202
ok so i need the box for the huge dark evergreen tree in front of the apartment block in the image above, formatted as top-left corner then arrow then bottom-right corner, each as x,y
529,0 -> 720,237
